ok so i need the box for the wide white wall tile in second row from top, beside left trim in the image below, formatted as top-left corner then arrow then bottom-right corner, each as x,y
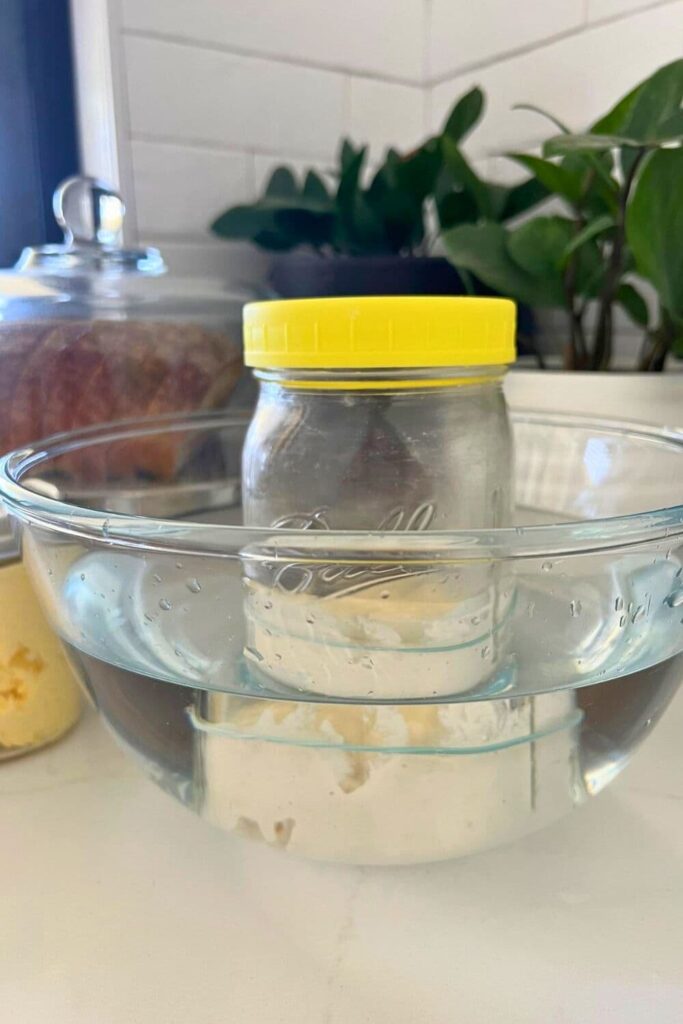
125,38 -> 344,157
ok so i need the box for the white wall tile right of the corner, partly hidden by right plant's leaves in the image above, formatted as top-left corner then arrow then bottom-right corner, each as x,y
431,0 -> 683,156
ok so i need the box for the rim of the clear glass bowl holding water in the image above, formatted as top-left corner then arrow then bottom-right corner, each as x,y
0,410 -> 683,562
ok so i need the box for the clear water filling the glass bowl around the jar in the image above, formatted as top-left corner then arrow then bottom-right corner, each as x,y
63,553 -> 683,863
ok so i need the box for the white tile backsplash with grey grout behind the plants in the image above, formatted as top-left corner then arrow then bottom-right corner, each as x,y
68,0 -> 683,365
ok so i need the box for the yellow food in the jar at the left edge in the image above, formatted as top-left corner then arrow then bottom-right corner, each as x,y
0,561 -> 80,758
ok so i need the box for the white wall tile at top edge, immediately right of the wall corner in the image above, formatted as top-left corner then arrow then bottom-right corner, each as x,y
427,0 -> 584,80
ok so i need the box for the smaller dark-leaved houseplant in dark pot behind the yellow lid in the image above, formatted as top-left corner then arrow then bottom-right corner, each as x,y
211,88 -> 547,297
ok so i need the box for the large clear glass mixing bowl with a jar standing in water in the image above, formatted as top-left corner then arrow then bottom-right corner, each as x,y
0,413 -> 683,863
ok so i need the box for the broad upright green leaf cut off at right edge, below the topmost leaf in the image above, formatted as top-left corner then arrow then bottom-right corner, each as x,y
626,148 -> 683,317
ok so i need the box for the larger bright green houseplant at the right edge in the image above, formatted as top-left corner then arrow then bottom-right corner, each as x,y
442,60 -> 683,370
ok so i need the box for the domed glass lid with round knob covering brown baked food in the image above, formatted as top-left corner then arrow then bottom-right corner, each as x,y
0,177 -> 244,456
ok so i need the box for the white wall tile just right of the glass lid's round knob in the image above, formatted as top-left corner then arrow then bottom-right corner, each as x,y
132,140 -> 251,238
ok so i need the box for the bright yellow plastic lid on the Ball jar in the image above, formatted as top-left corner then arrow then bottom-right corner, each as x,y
244,295 -> 515,370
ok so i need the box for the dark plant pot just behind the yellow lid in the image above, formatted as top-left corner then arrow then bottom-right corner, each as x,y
268,252 -> 536,354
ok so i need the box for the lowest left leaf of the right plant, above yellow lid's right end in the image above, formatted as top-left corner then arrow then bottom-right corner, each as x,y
442,222 -> 562,306
